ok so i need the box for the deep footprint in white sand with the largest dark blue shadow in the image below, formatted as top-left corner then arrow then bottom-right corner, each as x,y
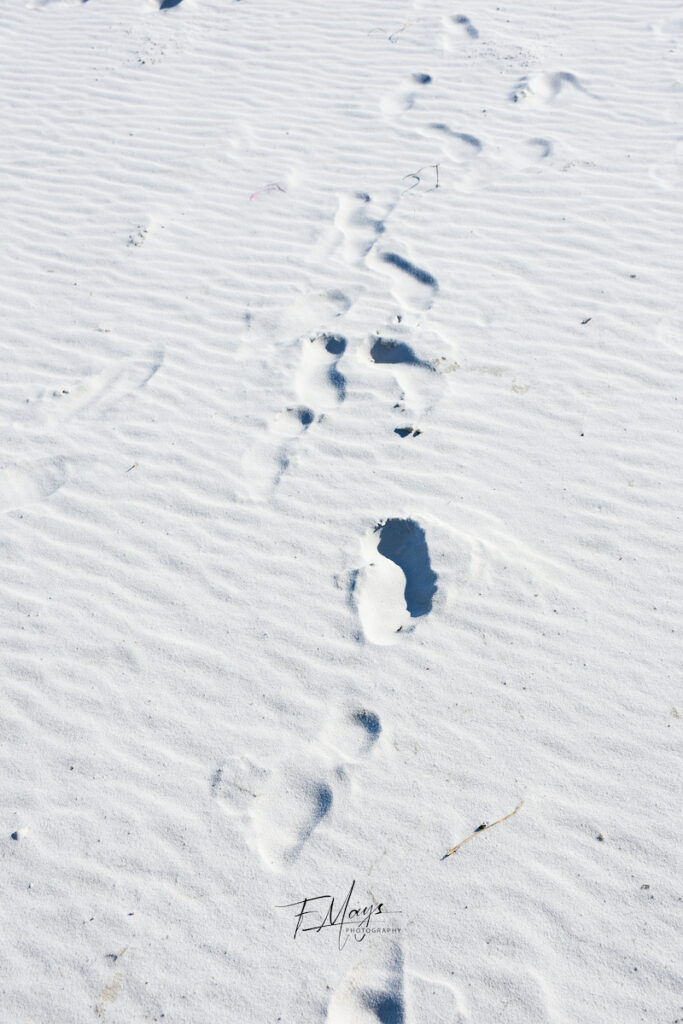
351,519 -> 438,646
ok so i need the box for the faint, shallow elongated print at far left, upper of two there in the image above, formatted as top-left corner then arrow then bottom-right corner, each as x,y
25,350 -> 164,423
